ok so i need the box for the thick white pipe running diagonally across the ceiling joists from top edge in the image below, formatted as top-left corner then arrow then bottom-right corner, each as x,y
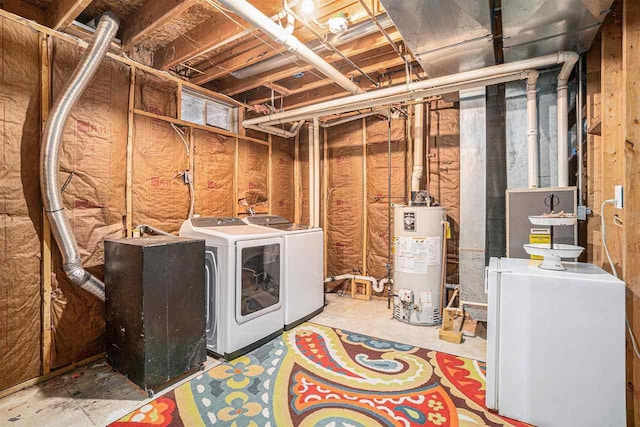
218,0 -> 363,93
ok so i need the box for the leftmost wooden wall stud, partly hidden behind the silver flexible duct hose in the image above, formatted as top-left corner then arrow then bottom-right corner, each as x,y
38,34 -> 53,375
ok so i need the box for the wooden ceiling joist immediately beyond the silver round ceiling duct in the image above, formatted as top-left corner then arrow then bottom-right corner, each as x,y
217,30 -> 402,95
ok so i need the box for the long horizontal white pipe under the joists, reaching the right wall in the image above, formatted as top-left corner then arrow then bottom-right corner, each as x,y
243,52 -> 576,126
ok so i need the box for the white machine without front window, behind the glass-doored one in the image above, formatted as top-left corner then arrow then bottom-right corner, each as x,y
243,215 -> 324,330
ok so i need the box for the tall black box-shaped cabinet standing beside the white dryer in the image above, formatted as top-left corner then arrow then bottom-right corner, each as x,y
104,236 -> 206,391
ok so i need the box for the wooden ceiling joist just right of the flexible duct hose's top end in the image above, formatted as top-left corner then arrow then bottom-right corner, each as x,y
120,0 -> 195,50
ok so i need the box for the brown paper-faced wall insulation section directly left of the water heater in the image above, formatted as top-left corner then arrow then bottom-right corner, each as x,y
367,118 -> 406,279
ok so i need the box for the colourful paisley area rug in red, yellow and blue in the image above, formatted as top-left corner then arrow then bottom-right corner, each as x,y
112,323 -> 525,427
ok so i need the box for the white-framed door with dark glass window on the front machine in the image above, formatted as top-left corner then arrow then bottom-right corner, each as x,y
235,237 -> 284,323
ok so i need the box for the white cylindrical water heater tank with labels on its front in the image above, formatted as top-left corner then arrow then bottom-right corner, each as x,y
393,206 -> 446,325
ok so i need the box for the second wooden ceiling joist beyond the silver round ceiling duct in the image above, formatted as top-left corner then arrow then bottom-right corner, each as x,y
246,52 -> 404,105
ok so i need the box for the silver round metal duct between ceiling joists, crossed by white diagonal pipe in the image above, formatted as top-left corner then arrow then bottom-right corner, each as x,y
231,14 -> 393,80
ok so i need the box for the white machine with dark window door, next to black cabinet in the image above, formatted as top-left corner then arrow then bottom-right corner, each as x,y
180,217 -> 285,360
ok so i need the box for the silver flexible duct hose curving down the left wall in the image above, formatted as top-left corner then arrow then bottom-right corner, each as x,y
40,12 -> 120,301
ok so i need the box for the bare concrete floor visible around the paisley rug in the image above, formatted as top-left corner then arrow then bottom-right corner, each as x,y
0,294 -> 486,427
